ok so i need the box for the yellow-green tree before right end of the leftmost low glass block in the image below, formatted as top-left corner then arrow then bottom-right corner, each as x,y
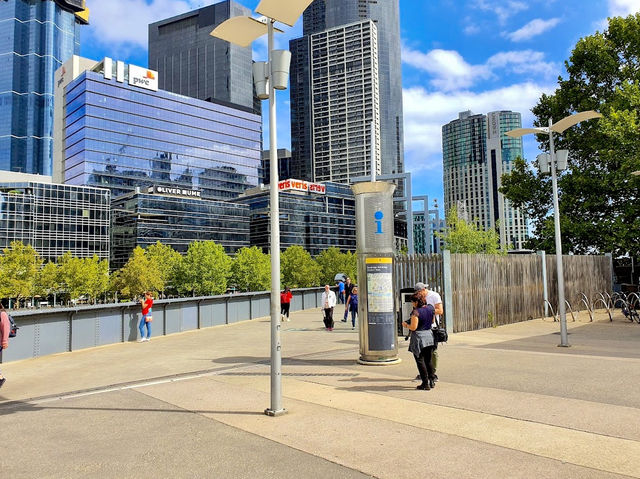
58,252 -> 109,300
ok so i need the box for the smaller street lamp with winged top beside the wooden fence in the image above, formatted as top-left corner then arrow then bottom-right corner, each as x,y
506,111 -> 602,347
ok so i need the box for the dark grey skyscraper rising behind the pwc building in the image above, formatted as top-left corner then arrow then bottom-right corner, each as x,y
149,0 -> 261,114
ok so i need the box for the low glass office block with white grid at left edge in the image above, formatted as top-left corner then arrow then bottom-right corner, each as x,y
0,181 -> 111,261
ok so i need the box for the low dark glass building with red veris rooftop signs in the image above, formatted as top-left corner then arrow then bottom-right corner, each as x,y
236,180 -> 356,256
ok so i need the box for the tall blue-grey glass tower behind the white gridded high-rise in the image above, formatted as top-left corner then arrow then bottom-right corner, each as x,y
290,0 -> 404,180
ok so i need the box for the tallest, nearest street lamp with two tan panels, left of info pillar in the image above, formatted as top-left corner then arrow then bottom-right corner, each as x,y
211,0 -> 312,416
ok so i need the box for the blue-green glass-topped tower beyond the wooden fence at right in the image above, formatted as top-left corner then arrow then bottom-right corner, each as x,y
442,111 -> 528,249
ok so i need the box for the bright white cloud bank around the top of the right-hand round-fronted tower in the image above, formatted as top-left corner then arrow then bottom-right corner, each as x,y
403,82 -> 556,179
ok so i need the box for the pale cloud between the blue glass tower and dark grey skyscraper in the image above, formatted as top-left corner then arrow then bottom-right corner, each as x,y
87,0 -> 202,50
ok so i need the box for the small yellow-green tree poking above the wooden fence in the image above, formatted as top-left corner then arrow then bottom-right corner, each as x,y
436,207 -> 506,254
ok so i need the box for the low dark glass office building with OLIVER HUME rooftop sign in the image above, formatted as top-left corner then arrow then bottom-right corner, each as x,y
111,187 -> 249,268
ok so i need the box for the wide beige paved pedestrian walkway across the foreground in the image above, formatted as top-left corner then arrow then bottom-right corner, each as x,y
0,310 -> 640,479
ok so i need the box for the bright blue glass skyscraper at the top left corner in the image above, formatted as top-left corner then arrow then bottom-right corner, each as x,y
0,0 -> 89,175
